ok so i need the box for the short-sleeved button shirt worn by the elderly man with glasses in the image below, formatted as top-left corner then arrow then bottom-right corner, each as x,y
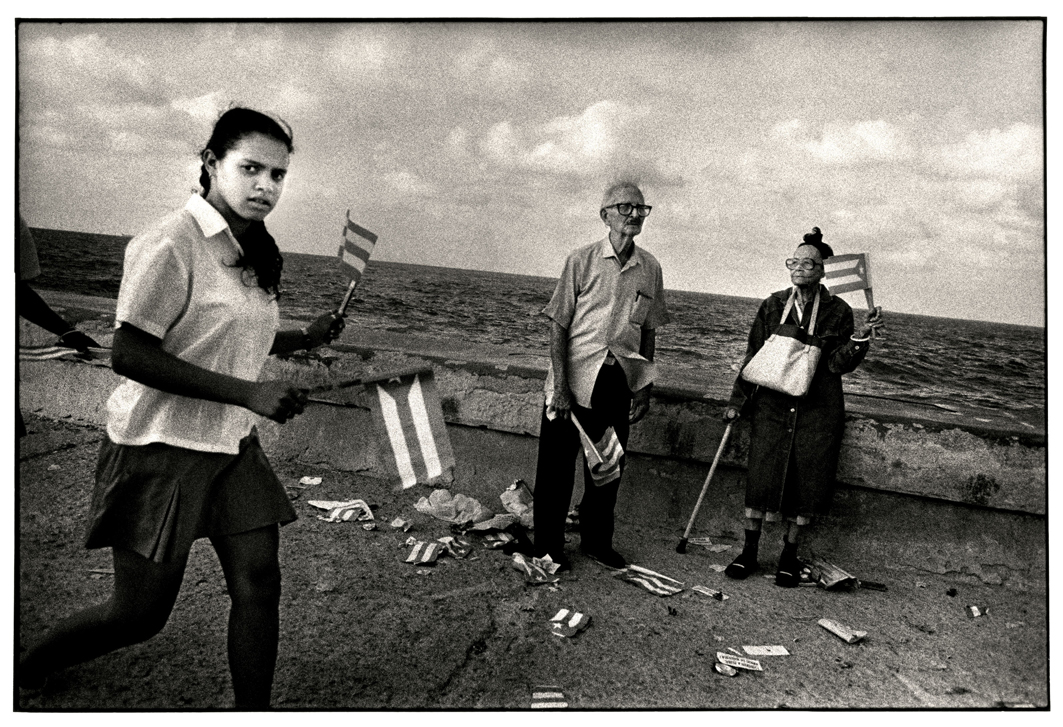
543,236 -> 671,407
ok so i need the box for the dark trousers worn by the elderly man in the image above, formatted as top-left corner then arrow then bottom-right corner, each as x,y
534,364 -> 631,560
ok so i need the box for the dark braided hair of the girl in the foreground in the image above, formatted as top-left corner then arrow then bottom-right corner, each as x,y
200,106 -> 294,299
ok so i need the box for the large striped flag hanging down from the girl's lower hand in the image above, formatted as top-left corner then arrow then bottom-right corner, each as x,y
365,369 -> 454,488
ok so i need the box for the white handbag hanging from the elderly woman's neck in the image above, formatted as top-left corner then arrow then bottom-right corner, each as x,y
741,288 -> 823,396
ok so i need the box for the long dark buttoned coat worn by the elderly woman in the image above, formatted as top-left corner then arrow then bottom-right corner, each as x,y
730,286 -> 868,517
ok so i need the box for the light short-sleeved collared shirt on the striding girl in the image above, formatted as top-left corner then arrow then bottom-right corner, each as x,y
107,195 -> 280,454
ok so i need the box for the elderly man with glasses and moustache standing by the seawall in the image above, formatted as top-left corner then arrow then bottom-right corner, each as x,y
535,182 -> 669,570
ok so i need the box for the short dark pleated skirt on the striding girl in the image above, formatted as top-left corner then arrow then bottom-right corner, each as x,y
85,432 -> 297,563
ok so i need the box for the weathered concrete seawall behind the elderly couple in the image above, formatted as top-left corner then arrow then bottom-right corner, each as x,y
14,292 -> 1047,588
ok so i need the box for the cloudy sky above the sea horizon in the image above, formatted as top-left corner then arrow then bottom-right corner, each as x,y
17,20 -> 1045,325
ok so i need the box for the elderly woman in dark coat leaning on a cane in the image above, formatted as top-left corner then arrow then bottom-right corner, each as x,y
724,227 -> 882,588
